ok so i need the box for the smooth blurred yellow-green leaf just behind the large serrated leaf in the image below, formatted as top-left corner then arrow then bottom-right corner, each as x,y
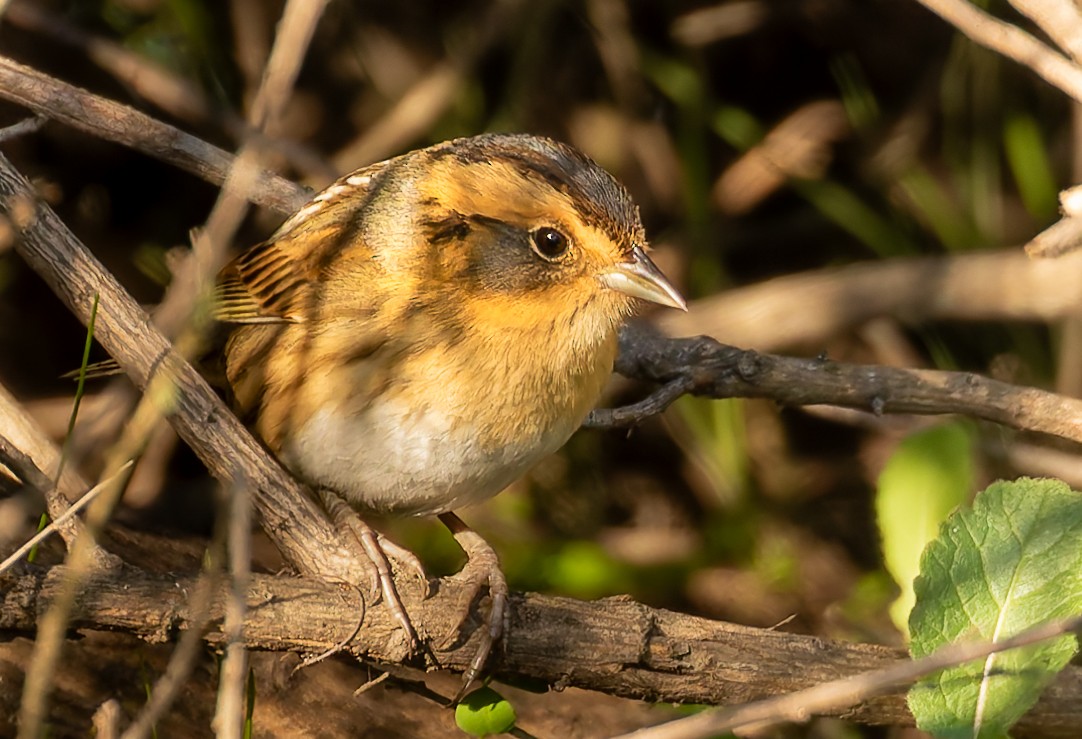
875,422 -> 974,634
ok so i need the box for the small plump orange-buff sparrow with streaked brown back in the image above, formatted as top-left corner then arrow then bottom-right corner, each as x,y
215,134 -> 686,695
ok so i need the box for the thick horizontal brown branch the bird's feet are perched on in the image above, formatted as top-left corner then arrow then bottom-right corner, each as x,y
0,568 -> 1082,737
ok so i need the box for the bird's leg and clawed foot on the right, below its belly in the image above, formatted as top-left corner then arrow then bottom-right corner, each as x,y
439,513 -> 510,703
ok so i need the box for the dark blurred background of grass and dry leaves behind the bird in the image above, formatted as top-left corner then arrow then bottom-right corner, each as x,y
0,0 -> 1079,735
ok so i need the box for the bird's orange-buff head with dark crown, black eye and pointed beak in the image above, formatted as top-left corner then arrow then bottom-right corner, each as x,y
412,134 -> 686,348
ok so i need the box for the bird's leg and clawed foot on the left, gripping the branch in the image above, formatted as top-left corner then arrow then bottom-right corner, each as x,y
319,489 -> 428,651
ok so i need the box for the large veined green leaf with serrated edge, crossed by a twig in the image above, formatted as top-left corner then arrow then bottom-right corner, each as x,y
909,478 -> 1082,739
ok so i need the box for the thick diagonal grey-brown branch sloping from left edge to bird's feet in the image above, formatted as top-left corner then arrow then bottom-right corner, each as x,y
0,157 -> 362,578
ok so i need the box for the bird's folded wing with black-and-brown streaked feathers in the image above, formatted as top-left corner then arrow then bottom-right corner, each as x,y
214,160 -> 394,324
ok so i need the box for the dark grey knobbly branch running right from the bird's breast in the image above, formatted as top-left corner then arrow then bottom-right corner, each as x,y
588,327 -> 1082,444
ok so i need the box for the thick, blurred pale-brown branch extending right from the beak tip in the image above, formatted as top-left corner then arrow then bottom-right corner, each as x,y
657,248 -> 1082,351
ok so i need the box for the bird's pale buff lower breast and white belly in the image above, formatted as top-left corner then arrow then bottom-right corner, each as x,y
283,333 -> 611,515
